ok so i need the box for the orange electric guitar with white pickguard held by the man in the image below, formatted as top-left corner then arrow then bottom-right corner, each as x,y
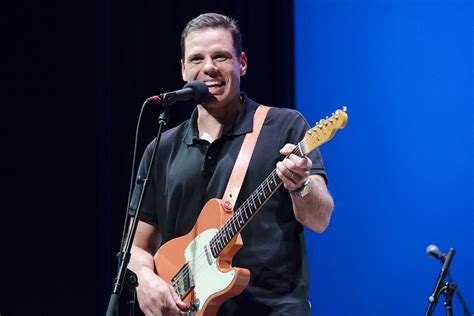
154,107 -> 348,316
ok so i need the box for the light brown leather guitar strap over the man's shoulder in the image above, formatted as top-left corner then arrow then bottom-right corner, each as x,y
222,105 -> 270,211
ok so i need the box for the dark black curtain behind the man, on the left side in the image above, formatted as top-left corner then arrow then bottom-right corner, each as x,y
0,0 -> 294,315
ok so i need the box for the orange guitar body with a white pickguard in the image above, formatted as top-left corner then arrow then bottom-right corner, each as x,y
154,199 -> 250,316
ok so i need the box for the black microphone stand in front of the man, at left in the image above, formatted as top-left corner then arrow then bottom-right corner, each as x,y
106,105 -> 169,316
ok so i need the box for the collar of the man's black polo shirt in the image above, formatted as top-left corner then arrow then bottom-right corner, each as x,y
183,92 -> 258,145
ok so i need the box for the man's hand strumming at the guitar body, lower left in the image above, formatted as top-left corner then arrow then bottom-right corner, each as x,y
137,268 -> 186,316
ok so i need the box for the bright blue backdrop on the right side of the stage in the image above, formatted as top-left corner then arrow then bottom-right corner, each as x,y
295,0 -> 474,316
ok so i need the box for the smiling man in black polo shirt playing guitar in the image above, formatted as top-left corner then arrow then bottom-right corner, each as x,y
129,13 -> 333,315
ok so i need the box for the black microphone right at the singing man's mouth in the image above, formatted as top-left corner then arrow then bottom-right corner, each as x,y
145,80 -> 209,107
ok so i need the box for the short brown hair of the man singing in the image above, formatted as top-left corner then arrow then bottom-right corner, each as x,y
181,13 -> 242,59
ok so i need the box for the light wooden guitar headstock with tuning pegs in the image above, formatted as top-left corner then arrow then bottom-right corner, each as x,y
300,106 -> 348,154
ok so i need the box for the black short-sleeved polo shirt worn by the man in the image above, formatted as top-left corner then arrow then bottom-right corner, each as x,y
131,94 -> 326,315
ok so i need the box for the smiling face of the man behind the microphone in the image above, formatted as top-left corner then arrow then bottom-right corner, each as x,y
181,28 -> 247,107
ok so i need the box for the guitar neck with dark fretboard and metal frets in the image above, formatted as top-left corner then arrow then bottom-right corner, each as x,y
210,142 -> 307,258
